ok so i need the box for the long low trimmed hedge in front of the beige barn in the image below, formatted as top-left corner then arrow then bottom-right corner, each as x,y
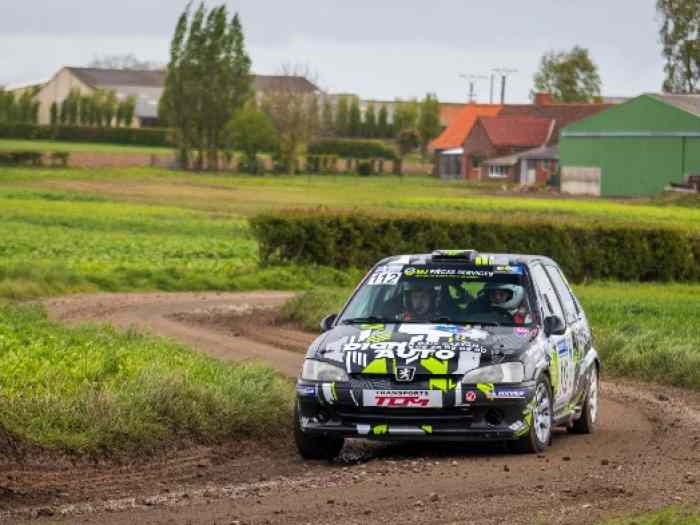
0,124 -> 173,147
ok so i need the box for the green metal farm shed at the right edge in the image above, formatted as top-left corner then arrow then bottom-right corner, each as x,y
560,95 -> 700,197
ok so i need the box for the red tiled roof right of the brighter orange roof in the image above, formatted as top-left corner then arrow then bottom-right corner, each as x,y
479,115 -> 553,147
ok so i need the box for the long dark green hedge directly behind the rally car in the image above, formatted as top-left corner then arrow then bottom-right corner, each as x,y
251,210 -> 700,282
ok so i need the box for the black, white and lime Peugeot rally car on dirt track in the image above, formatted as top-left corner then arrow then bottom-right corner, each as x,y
294,250 -> 600,459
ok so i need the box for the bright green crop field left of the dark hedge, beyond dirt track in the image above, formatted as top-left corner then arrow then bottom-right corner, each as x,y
0,188 -> 360,299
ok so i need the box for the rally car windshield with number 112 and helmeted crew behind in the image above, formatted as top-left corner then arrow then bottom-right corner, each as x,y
340,263 -> 532,326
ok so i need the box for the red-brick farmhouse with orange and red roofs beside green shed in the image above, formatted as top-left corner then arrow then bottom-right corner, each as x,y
432,93 -> 612,184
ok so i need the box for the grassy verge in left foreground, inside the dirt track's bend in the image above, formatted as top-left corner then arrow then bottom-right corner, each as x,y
0,306 -> 293,453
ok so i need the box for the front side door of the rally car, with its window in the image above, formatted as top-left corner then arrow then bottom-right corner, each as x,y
531,263 -> 576,414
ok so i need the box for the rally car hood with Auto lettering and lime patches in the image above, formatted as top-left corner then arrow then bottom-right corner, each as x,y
307,323 -> 537,375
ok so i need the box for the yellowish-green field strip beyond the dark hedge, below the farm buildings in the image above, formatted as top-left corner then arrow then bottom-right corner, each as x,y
0,168 -> 700,230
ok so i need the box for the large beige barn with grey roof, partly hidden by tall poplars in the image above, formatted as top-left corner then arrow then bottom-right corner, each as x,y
15,67 -> 321,127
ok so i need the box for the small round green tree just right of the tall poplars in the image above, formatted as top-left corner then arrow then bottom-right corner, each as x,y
227,106 -> 278,173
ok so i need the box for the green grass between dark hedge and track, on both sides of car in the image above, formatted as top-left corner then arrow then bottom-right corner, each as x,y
283,283 -> 700,390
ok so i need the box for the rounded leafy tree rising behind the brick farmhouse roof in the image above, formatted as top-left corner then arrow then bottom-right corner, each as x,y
534,46 -> 601,102
